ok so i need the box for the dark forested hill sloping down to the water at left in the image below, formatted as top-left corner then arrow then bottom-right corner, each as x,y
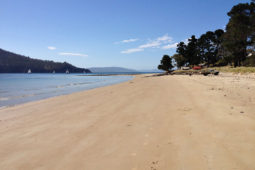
0,49 -> 91,73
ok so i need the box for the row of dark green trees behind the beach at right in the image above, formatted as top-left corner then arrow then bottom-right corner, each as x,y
158,0 -> 255,71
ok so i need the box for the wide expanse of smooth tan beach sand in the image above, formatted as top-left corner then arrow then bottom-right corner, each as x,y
0,75 -> 255,170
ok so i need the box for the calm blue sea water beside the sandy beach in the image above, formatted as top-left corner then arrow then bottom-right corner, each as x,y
0,74 -> 133,107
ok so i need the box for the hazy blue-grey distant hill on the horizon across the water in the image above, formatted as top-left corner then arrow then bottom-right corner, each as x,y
89,67 -> 138,73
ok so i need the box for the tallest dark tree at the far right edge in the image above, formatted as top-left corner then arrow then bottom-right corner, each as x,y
223,3 -> 255,66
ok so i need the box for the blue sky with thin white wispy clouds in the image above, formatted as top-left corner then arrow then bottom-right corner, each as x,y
0,0 -> 250,70
